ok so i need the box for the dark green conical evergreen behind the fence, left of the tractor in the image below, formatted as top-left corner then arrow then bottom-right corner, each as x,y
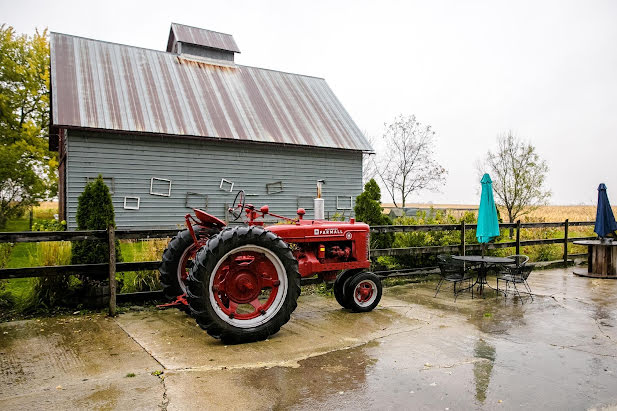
71,175 -> 122,279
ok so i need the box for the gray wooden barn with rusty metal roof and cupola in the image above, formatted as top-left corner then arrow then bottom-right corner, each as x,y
49,23 -> 372,229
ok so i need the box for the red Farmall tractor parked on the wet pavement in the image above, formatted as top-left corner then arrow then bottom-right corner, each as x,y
159,191 -> 382,343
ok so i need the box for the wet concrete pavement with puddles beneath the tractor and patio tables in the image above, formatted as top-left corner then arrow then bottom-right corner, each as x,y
0,270 -> 617,410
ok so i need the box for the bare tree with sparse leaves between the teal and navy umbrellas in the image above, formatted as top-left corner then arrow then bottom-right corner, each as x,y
478,132 -> 551,223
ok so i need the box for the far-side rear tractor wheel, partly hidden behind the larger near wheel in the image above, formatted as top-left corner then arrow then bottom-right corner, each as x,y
159,225 -> 218,301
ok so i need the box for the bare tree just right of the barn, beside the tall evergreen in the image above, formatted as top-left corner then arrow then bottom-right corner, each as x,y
376,115 -> 447,207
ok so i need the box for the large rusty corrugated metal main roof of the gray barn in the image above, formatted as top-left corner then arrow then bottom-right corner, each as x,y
50,33 -> 372,151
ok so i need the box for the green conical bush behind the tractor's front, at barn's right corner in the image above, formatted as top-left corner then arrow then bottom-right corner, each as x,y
354,178 -> 394,248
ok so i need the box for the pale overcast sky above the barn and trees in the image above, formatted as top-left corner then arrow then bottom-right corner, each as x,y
0,0 -> 617,204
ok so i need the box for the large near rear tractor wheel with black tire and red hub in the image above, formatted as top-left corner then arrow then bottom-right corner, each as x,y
187,226 -> 300,344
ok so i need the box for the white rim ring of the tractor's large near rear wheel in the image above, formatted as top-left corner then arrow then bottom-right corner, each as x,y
208,245 -> 287,328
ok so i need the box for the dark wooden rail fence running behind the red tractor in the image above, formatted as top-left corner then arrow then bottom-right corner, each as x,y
0,220 -> 595,315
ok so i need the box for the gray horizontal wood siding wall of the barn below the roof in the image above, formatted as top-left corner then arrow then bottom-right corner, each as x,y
66,131 -> 362,230
